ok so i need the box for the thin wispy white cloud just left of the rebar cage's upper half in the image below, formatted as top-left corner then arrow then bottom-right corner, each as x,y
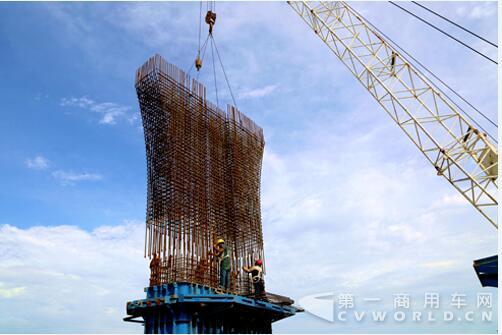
60,97 -> 138,125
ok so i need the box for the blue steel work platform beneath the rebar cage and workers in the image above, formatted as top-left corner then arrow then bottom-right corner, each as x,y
124,283 -> 301,334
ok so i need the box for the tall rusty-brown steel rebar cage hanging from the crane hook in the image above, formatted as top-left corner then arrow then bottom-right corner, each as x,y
136,55 -> 265,294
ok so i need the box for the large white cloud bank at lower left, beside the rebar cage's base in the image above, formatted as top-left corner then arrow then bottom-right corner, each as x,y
0,221 -> 149,333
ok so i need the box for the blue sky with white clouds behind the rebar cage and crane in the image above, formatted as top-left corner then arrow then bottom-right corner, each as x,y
0,2 -> 497,332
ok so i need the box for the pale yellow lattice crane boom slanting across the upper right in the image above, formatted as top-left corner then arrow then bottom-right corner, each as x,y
288,1 -> 498,227
